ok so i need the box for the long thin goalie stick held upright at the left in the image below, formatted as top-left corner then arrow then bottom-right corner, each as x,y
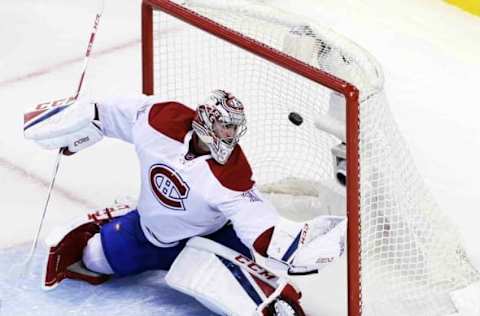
23,0 -> 105,272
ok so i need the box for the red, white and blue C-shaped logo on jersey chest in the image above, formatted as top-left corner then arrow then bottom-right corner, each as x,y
150,164 -> 190,211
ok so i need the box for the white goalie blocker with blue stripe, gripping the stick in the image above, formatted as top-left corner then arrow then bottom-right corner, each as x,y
23,98 -> 103,153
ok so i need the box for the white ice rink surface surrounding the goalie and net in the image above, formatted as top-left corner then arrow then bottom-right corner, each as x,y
0,0 -> 480,315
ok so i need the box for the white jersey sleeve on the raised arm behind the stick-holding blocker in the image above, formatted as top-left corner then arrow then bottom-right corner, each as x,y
97,95 -> 156,143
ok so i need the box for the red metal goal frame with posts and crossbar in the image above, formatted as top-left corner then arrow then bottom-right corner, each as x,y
142,0 -> 362,316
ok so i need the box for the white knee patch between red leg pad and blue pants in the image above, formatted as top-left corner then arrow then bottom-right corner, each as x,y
82,234 -> 114,274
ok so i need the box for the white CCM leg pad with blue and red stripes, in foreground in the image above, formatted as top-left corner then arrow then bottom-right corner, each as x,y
165,237 -> 304,316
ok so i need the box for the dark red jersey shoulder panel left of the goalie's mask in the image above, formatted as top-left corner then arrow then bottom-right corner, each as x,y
148,102 -> 195,143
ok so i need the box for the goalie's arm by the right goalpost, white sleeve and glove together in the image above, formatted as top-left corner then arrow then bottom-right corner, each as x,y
218,186 -> 346,274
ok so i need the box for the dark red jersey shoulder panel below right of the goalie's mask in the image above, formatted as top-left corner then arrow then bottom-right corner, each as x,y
207,145 -> 255,192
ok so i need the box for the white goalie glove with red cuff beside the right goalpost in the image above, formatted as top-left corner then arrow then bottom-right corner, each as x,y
254,216 -> 346,275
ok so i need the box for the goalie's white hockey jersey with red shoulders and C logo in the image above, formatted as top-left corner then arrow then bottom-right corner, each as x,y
97,96 -> 278,247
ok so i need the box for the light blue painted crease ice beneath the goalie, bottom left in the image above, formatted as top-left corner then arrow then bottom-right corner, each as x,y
0,244 -> 214,316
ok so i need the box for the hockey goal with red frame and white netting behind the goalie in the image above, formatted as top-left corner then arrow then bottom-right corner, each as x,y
142,0 -> 479,316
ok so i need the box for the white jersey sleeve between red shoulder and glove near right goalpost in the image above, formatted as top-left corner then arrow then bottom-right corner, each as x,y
216,186 -> 279,249
